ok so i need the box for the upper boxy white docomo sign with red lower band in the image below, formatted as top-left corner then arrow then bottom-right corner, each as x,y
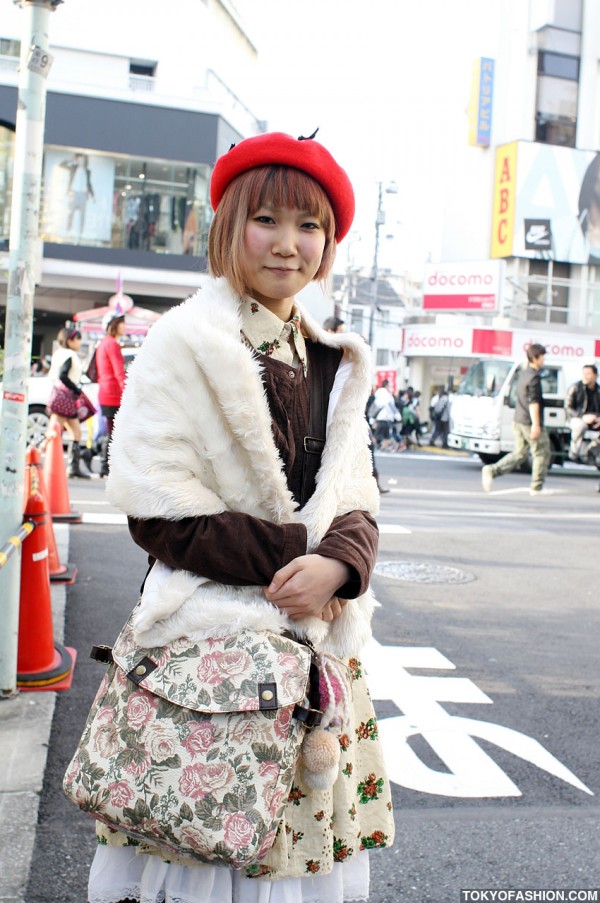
423,260 -> 502,311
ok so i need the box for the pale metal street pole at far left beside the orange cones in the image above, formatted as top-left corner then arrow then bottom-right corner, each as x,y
0,0 -> 61,698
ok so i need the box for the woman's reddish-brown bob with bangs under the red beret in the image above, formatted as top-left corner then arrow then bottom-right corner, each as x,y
208,166 -> 336,297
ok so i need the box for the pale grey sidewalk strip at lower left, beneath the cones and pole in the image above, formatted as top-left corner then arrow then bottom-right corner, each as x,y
0,524 -> 69,903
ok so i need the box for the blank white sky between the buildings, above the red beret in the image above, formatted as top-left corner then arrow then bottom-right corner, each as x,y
235,0 -> 502,273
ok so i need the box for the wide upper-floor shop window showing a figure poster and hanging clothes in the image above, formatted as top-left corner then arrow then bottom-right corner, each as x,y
41,147 -> 210,257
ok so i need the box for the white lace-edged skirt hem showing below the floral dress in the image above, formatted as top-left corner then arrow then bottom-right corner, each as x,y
88,845 -> 369,903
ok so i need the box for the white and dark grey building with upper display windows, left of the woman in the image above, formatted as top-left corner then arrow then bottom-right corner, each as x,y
0,0 -> 264,356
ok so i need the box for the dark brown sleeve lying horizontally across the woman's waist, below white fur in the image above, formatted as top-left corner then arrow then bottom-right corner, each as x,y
129,511 -> 306,586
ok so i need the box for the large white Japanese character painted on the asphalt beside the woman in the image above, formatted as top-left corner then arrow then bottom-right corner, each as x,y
362,640 -> 593,798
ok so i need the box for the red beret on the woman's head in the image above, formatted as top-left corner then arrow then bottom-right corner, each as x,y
210,132 -> 354,242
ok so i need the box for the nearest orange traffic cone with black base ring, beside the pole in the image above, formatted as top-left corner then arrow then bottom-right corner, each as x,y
17,485 -> 77,690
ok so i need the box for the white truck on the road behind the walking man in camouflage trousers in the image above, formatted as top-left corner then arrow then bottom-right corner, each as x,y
448,358 -> 600,469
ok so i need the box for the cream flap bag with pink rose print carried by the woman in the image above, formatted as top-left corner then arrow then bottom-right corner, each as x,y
63,618 -> 319,869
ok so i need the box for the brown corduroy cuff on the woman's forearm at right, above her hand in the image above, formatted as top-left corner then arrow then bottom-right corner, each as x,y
315,511 -> 379,599
